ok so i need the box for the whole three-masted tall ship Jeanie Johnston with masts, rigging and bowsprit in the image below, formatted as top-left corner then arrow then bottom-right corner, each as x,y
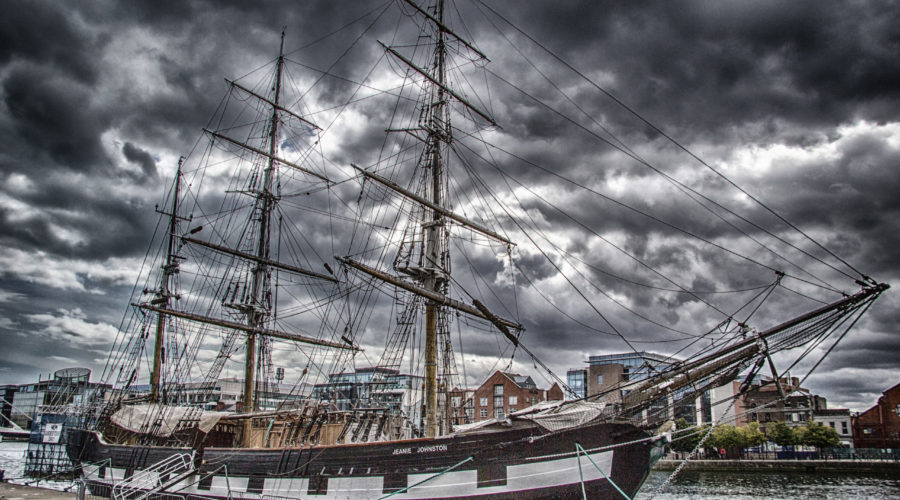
66,0 -> 888,499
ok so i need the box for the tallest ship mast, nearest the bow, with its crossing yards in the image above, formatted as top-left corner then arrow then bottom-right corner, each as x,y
348,0 -> 506,437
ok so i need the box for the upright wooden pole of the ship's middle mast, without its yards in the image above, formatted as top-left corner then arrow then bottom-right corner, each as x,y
242,31 -> 284,413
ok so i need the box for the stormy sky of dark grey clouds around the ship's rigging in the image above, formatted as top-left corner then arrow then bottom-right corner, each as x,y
0,0 -> 900,410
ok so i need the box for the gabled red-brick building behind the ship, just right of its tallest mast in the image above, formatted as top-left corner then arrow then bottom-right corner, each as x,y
472,371 -> 563,422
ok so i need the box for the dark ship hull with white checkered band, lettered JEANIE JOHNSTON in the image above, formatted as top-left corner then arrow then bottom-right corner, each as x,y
69,423 -> 659,499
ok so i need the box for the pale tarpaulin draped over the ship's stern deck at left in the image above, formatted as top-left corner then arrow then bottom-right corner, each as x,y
111,405 -> 229,437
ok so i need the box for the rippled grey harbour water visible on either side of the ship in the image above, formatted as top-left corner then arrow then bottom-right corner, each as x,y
0,442 -> 900,500
